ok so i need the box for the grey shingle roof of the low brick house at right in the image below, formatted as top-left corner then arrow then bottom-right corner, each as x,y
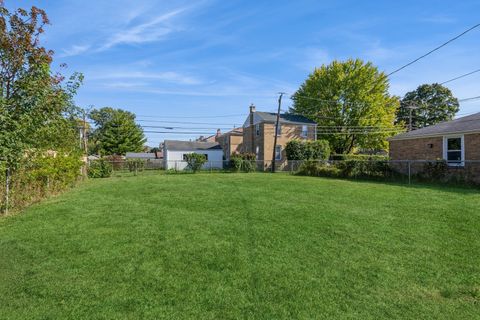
390,112 -> 480,140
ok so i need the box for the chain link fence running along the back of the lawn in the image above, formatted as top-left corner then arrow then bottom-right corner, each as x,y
94,159 -> 480,185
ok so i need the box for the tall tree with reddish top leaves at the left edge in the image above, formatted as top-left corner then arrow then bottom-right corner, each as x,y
0,1 -> 82,168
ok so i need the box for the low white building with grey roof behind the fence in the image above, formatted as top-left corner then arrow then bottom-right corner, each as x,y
163,140 -> 223,170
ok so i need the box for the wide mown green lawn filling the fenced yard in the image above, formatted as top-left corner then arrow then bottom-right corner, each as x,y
0,173 -> 480,319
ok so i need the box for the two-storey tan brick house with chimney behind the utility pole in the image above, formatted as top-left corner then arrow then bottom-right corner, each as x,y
243,105 -> 317,166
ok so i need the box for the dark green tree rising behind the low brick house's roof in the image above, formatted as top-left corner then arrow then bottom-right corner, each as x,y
396,83 -> 459,129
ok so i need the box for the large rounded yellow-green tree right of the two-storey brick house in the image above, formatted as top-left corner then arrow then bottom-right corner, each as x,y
290,59 -> 399,154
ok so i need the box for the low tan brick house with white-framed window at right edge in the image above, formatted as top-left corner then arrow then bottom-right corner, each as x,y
389,112 -> 480,180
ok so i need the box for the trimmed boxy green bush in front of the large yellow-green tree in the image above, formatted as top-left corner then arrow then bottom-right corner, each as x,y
285,140 -> 330,160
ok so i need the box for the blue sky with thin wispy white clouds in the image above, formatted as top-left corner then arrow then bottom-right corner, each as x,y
6,0 -> 480,146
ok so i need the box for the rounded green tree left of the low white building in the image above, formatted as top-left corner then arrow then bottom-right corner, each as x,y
90,107 -> 146,155
